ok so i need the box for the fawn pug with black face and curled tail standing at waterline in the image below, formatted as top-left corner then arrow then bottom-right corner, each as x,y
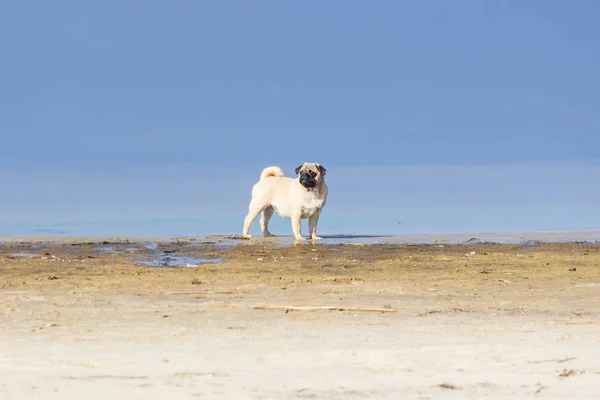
242,163 -> 327,241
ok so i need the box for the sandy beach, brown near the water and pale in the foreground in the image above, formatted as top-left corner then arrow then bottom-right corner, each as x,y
0,239 -> 600,400
